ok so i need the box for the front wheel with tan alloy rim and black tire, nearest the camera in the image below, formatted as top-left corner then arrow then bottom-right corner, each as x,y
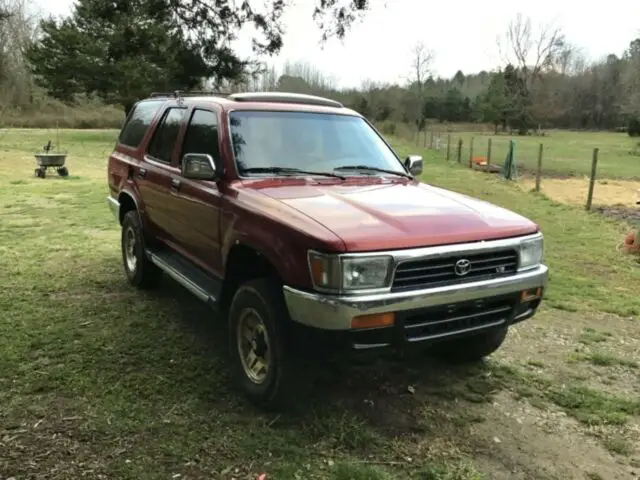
229,278 -> 310,408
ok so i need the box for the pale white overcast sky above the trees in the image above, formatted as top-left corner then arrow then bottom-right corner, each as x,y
36,0 -> 640,86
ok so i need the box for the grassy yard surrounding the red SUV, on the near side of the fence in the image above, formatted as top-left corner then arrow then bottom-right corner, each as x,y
0,130 -> 640,480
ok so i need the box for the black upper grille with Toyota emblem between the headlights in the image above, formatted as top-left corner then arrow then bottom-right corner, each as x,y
392,250 -> 518,291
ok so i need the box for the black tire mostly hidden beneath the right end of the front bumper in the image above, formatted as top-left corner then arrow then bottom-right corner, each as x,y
432,326 -> 508,363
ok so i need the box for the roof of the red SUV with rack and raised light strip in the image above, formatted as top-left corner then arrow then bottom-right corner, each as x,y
142,92 -> 362,117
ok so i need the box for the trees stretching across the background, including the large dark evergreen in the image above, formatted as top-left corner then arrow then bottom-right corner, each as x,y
0,0 -> 640,135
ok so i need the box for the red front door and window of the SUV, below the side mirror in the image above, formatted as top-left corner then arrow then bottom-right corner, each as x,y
173,107 -> 223,275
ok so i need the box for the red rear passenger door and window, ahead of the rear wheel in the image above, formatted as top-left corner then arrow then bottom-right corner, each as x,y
138,106 -> 187,243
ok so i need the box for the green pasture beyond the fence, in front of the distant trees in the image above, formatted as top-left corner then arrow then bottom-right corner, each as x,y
418,130 -> 640,179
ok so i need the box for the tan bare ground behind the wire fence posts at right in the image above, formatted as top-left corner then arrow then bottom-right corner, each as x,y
520,177 -> 640,206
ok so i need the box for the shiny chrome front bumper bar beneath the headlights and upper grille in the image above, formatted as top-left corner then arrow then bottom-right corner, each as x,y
283,265 -> 549,330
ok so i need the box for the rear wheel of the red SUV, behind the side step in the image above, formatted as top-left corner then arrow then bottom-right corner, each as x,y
120,210 -> 162,289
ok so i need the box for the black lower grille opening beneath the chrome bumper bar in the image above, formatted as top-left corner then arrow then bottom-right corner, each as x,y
404,295 -> 517,342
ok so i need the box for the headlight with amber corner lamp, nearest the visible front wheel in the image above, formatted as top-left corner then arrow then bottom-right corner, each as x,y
309,251 -> 392,292
